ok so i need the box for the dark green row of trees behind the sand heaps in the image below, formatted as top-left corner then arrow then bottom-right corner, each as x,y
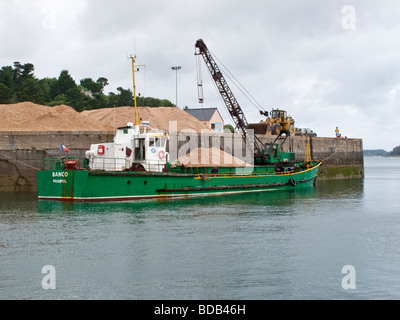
0,62 -> 174,112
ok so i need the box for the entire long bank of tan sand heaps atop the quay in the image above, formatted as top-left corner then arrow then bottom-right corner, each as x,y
0,102 -> 208,132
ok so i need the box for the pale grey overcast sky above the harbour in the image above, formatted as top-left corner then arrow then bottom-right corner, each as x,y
0,0 -> 400,151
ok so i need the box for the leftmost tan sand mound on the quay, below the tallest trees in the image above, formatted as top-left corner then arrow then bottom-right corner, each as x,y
0,102 -> 113,131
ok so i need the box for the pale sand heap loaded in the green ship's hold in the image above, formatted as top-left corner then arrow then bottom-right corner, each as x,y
172,148 -> 250,167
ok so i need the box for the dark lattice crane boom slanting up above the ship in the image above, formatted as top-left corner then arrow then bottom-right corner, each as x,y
195,39 -> 262,159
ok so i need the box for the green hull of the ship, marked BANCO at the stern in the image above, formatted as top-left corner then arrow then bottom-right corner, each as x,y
37,161 -> 321,201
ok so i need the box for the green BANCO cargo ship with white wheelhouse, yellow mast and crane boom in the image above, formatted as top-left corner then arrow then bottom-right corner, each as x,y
37,40 -> 321,201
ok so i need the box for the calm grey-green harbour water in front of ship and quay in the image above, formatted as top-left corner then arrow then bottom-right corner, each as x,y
0,158 -> 400,300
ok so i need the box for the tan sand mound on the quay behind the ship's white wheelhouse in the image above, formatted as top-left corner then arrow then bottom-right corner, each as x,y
82,107 -> 208,132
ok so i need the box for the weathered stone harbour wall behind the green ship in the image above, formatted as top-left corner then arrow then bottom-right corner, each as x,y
0,131 -> 364,192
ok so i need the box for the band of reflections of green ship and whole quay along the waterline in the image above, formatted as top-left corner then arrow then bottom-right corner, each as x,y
0,179 -> 364,219
